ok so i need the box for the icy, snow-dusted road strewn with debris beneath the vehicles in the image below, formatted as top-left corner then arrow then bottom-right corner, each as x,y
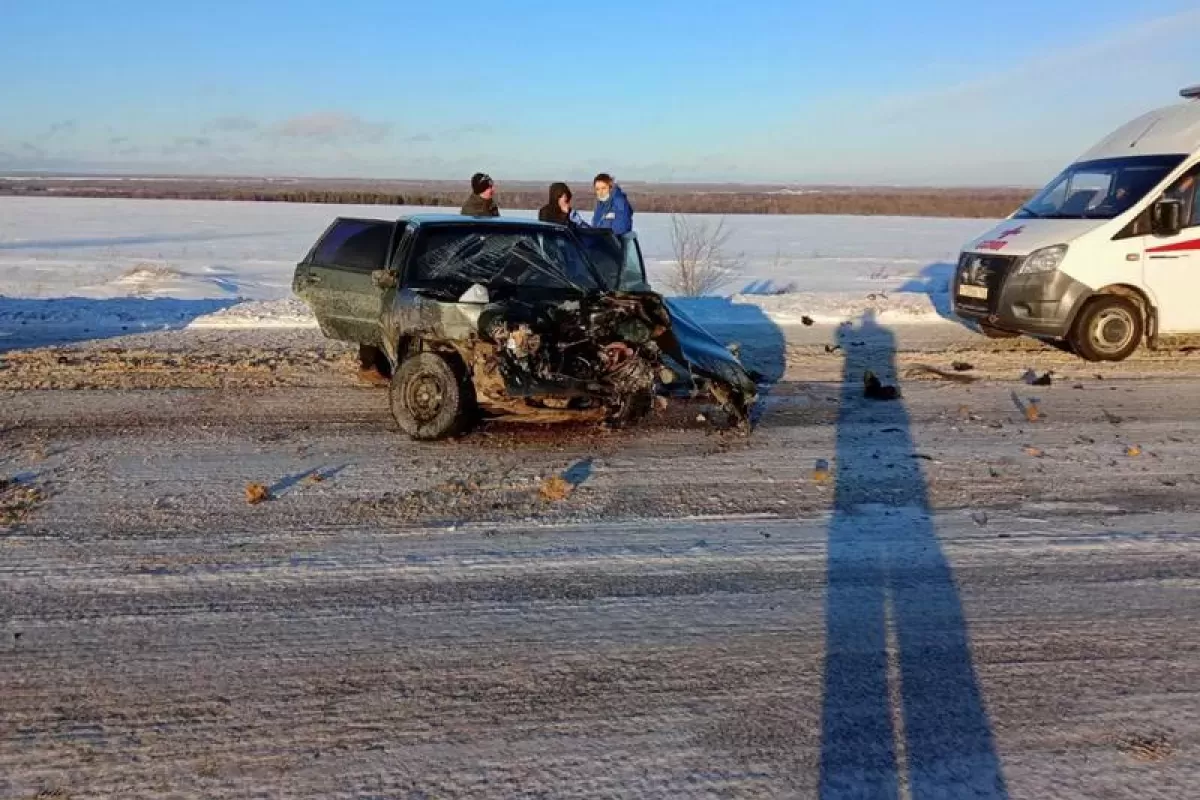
0,331 -> 1200,800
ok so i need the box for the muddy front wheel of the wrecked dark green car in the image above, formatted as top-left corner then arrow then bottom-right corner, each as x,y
389,353 -> 475,440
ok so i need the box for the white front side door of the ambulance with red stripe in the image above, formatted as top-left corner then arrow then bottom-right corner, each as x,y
1142,166 -> 1200,333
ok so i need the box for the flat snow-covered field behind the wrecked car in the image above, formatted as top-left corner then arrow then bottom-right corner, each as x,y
0,198 -> 990,338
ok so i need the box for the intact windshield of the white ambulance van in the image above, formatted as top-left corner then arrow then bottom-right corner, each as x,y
1014,156 -> 1183,219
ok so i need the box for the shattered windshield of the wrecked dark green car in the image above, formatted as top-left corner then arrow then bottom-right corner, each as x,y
408,225 -> 601,300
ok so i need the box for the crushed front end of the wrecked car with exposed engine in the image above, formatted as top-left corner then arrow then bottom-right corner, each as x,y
383,224 -> 757,425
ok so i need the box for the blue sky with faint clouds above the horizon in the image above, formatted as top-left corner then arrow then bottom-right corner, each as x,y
0,0 -> 1200,185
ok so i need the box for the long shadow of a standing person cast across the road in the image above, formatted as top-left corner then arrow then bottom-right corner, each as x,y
821,315 -> 1008,800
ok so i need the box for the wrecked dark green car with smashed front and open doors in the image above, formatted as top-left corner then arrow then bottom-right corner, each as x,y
293,216 -> 757,439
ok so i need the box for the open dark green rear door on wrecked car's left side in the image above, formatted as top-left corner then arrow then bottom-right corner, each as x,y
296,218 -> 403,345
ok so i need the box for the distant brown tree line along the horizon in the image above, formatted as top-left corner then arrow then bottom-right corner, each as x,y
0,179 -> 1030,218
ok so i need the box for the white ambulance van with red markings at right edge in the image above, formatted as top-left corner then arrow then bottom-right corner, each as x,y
950,86 -> 1200,361
